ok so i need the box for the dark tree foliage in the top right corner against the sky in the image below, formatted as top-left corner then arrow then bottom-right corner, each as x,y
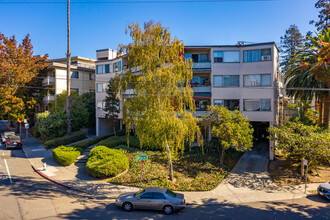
309,0 -> 330,31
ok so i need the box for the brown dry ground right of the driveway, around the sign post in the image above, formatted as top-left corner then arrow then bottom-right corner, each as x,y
268,156 -> 330,186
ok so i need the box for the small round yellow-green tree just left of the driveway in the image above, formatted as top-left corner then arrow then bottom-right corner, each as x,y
204,106 -> 253,165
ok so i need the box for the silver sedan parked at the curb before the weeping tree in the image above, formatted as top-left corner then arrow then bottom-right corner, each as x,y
116,187 -> 186,215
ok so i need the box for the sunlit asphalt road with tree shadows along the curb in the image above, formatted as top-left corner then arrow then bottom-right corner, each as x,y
0,138 -> 330,220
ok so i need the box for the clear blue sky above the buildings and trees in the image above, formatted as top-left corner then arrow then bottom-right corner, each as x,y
0,0 -> 318,58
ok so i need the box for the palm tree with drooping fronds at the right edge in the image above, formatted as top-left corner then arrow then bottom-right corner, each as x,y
285,28 -> 330,126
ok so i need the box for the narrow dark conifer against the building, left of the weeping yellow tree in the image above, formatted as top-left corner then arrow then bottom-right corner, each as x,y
103,78 -> 120,136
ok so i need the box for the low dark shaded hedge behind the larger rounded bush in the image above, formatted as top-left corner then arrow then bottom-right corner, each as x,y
97,136 -> 140,148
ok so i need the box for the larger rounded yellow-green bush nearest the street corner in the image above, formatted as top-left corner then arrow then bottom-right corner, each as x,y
86,146 -> 129,178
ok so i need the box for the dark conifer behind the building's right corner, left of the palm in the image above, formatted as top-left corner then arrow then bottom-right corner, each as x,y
280,25 -> 304,73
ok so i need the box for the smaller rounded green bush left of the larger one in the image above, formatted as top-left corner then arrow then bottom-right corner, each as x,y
53,146 -> 82,166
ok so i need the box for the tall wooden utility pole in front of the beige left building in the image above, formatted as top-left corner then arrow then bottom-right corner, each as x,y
66,0 -> 71,135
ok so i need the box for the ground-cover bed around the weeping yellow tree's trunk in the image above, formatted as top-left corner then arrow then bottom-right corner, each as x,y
108,146 -> 242,191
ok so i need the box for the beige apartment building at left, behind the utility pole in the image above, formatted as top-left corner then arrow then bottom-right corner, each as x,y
36,56 -> 95,112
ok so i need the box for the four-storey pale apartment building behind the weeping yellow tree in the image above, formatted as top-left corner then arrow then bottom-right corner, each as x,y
96,42 -> 284,159
